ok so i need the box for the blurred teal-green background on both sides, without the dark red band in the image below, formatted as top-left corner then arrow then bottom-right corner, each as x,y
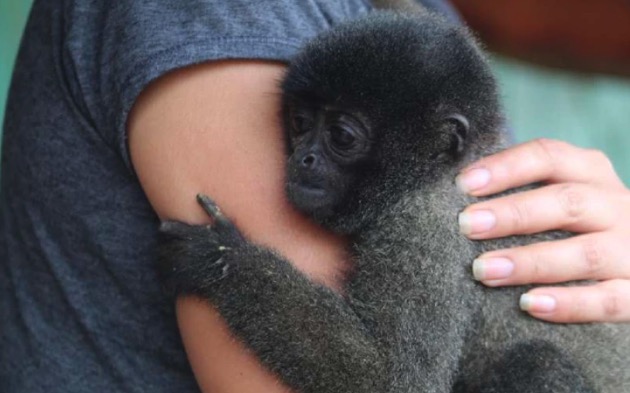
0,0 -> 630,184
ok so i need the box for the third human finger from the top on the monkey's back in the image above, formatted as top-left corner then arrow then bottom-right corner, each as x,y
473,232 -> 630,287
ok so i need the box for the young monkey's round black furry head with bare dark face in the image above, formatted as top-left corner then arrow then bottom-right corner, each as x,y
282,13 -> 502,233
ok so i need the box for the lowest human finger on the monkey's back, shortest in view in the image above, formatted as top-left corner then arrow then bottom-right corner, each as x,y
520,280 -> 630,323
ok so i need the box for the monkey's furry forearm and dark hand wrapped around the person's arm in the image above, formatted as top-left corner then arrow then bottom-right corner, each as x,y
159,196 -> 384,393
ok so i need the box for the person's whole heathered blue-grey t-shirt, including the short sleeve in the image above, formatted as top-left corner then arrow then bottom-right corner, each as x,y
0,0 -> 460,393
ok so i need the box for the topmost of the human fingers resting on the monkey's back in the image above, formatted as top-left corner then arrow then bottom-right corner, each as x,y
457,139 -> 624,196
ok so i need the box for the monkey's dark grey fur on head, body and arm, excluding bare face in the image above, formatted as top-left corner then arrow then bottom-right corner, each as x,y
160,9 -> 630,393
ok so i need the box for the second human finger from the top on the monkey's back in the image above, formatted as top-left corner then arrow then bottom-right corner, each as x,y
459,183 -> 630,239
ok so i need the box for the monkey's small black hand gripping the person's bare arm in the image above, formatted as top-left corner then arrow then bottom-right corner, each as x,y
158,194 -> 247,295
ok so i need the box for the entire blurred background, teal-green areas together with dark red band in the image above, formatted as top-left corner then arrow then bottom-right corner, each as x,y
0,0 -> 630,184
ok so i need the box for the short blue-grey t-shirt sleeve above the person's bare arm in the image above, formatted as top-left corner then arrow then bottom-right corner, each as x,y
56,0 -> 369,170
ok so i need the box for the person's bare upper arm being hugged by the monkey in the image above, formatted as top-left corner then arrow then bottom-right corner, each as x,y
127,61 -> 354,393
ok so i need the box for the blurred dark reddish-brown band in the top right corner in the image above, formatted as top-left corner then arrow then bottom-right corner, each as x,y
452,0 -> 630,76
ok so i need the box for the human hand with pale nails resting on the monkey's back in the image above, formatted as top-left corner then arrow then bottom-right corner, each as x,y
457,139 -> 630,323
